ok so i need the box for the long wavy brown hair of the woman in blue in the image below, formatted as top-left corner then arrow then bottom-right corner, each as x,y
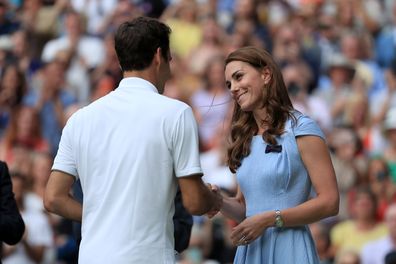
225,46 -> 294,173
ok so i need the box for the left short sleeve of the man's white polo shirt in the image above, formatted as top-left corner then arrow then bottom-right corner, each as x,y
52,115 -> 78,179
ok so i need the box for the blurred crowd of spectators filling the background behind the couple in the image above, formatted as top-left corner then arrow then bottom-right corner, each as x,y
0,0 -> 396,264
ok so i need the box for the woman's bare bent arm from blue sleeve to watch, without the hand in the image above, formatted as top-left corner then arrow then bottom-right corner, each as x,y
281,136 -> 339,226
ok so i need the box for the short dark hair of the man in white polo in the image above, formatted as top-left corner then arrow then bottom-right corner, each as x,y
114,17 -> 171,71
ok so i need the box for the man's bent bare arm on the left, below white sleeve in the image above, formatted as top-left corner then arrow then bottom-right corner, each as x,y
44,170 -> 82,222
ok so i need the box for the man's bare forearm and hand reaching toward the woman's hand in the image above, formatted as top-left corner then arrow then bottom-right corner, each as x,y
178,174 -> 223,215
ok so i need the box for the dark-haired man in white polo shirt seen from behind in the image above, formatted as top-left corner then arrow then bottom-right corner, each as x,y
44,17 -> 222,264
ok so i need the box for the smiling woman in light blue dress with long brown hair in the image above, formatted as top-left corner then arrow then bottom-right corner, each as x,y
221,47 -> 339,264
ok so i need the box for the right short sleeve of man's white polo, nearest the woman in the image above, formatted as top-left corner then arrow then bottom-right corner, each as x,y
172,107 -> 202,177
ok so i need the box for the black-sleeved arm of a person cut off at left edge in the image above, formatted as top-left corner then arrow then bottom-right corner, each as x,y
0,162 -> 25,245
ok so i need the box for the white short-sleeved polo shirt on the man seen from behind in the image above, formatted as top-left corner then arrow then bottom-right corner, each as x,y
52,78 -> 202,264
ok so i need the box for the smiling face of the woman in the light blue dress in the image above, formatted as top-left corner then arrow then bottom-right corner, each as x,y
225,61 -> 267,112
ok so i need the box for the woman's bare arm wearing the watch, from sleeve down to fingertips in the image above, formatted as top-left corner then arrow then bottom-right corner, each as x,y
231,136 -> 339,245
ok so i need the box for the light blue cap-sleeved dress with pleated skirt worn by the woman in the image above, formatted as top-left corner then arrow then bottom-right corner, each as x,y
234,112 -> 324,264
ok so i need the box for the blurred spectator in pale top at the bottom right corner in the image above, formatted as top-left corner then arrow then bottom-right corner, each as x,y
361,204 -> 396,264
